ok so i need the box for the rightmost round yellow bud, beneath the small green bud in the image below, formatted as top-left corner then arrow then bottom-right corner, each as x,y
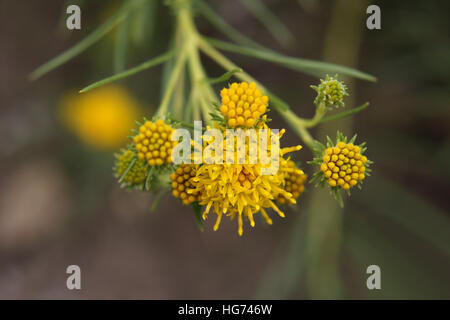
320,142 -> 367,190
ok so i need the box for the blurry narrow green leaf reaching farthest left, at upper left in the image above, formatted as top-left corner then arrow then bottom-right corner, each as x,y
29,7 -> 129,81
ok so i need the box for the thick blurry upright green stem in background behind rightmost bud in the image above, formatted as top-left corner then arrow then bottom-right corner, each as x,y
304,0 -> 368,299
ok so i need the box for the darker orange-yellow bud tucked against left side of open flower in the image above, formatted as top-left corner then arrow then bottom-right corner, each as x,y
170,164 -> 200,205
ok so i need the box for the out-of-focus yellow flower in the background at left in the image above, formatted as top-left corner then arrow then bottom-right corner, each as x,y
61,86 -> 138,150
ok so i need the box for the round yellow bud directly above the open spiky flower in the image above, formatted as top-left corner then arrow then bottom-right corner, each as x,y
220,82 -> 269,128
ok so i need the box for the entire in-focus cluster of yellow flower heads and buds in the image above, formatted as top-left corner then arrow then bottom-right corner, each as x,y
115,77 -> 372,235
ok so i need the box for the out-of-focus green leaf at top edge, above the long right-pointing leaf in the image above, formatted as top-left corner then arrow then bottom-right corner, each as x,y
241,0 -> 295,46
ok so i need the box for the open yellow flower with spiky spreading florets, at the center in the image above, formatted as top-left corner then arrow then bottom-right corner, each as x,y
188,130 -> 301,235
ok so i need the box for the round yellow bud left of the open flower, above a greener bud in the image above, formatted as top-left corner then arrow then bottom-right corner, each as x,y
133,120 -> 177,166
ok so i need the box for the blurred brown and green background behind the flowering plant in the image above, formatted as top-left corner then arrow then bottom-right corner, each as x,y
0,0 -> 450,299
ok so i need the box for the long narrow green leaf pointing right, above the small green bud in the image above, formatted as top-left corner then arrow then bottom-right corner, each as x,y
207,38 -> 376,82
